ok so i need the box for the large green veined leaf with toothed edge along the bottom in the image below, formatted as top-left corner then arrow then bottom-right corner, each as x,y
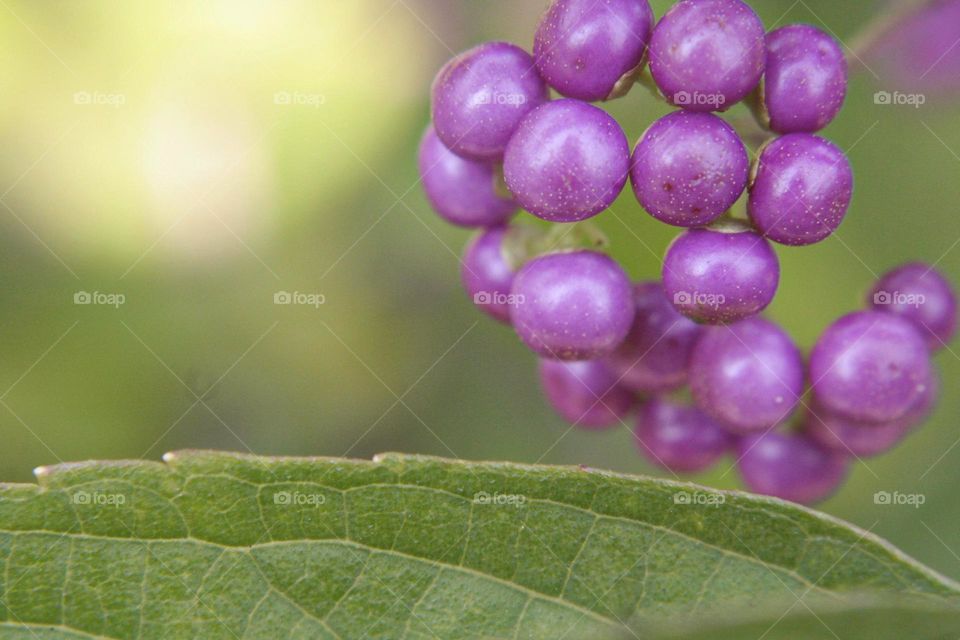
0,451 -> 960,640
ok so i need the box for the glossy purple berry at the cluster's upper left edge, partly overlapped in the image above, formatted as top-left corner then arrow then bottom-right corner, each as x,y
431,42 -> 550,162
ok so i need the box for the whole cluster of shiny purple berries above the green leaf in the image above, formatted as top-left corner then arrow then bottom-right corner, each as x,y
419,0 -> 956,503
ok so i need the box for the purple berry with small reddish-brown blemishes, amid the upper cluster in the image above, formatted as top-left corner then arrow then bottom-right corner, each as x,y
630,111 -> 750,227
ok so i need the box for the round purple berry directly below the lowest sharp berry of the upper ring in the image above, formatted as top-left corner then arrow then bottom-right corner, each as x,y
690,317 -> 804,433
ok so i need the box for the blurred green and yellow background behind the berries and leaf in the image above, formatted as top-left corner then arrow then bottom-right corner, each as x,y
0,0 -> 960,577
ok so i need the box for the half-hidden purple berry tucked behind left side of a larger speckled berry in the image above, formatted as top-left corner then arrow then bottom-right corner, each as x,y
460,226 -> 515,323
